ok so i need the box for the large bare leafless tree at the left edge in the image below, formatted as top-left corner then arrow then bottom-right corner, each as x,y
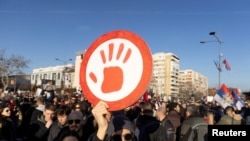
0,50 -> 30,90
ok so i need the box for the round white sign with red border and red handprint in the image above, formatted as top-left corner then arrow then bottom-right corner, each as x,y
80,30 -> 152,111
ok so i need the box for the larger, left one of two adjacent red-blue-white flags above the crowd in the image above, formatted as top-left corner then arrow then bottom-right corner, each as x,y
214,84 -> 234,108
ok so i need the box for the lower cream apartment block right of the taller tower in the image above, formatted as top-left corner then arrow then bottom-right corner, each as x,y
179,69 -> 208,98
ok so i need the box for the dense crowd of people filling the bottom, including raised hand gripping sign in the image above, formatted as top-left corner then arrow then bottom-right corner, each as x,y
0,89 -> 250,141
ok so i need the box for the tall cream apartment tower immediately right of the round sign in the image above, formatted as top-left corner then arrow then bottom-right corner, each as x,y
149,52 -> 180,98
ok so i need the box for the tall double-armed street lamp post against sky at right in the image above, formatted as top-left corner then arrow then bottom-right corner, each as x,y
200,32 -> 223,89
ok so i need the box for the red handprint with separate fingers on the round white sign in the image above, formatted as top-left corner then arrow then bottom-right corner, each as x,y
89,43 -> 132,93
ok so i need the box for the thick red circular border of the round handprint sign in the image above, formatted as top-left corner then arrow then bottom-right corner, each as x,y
80,30 -> 153,111
